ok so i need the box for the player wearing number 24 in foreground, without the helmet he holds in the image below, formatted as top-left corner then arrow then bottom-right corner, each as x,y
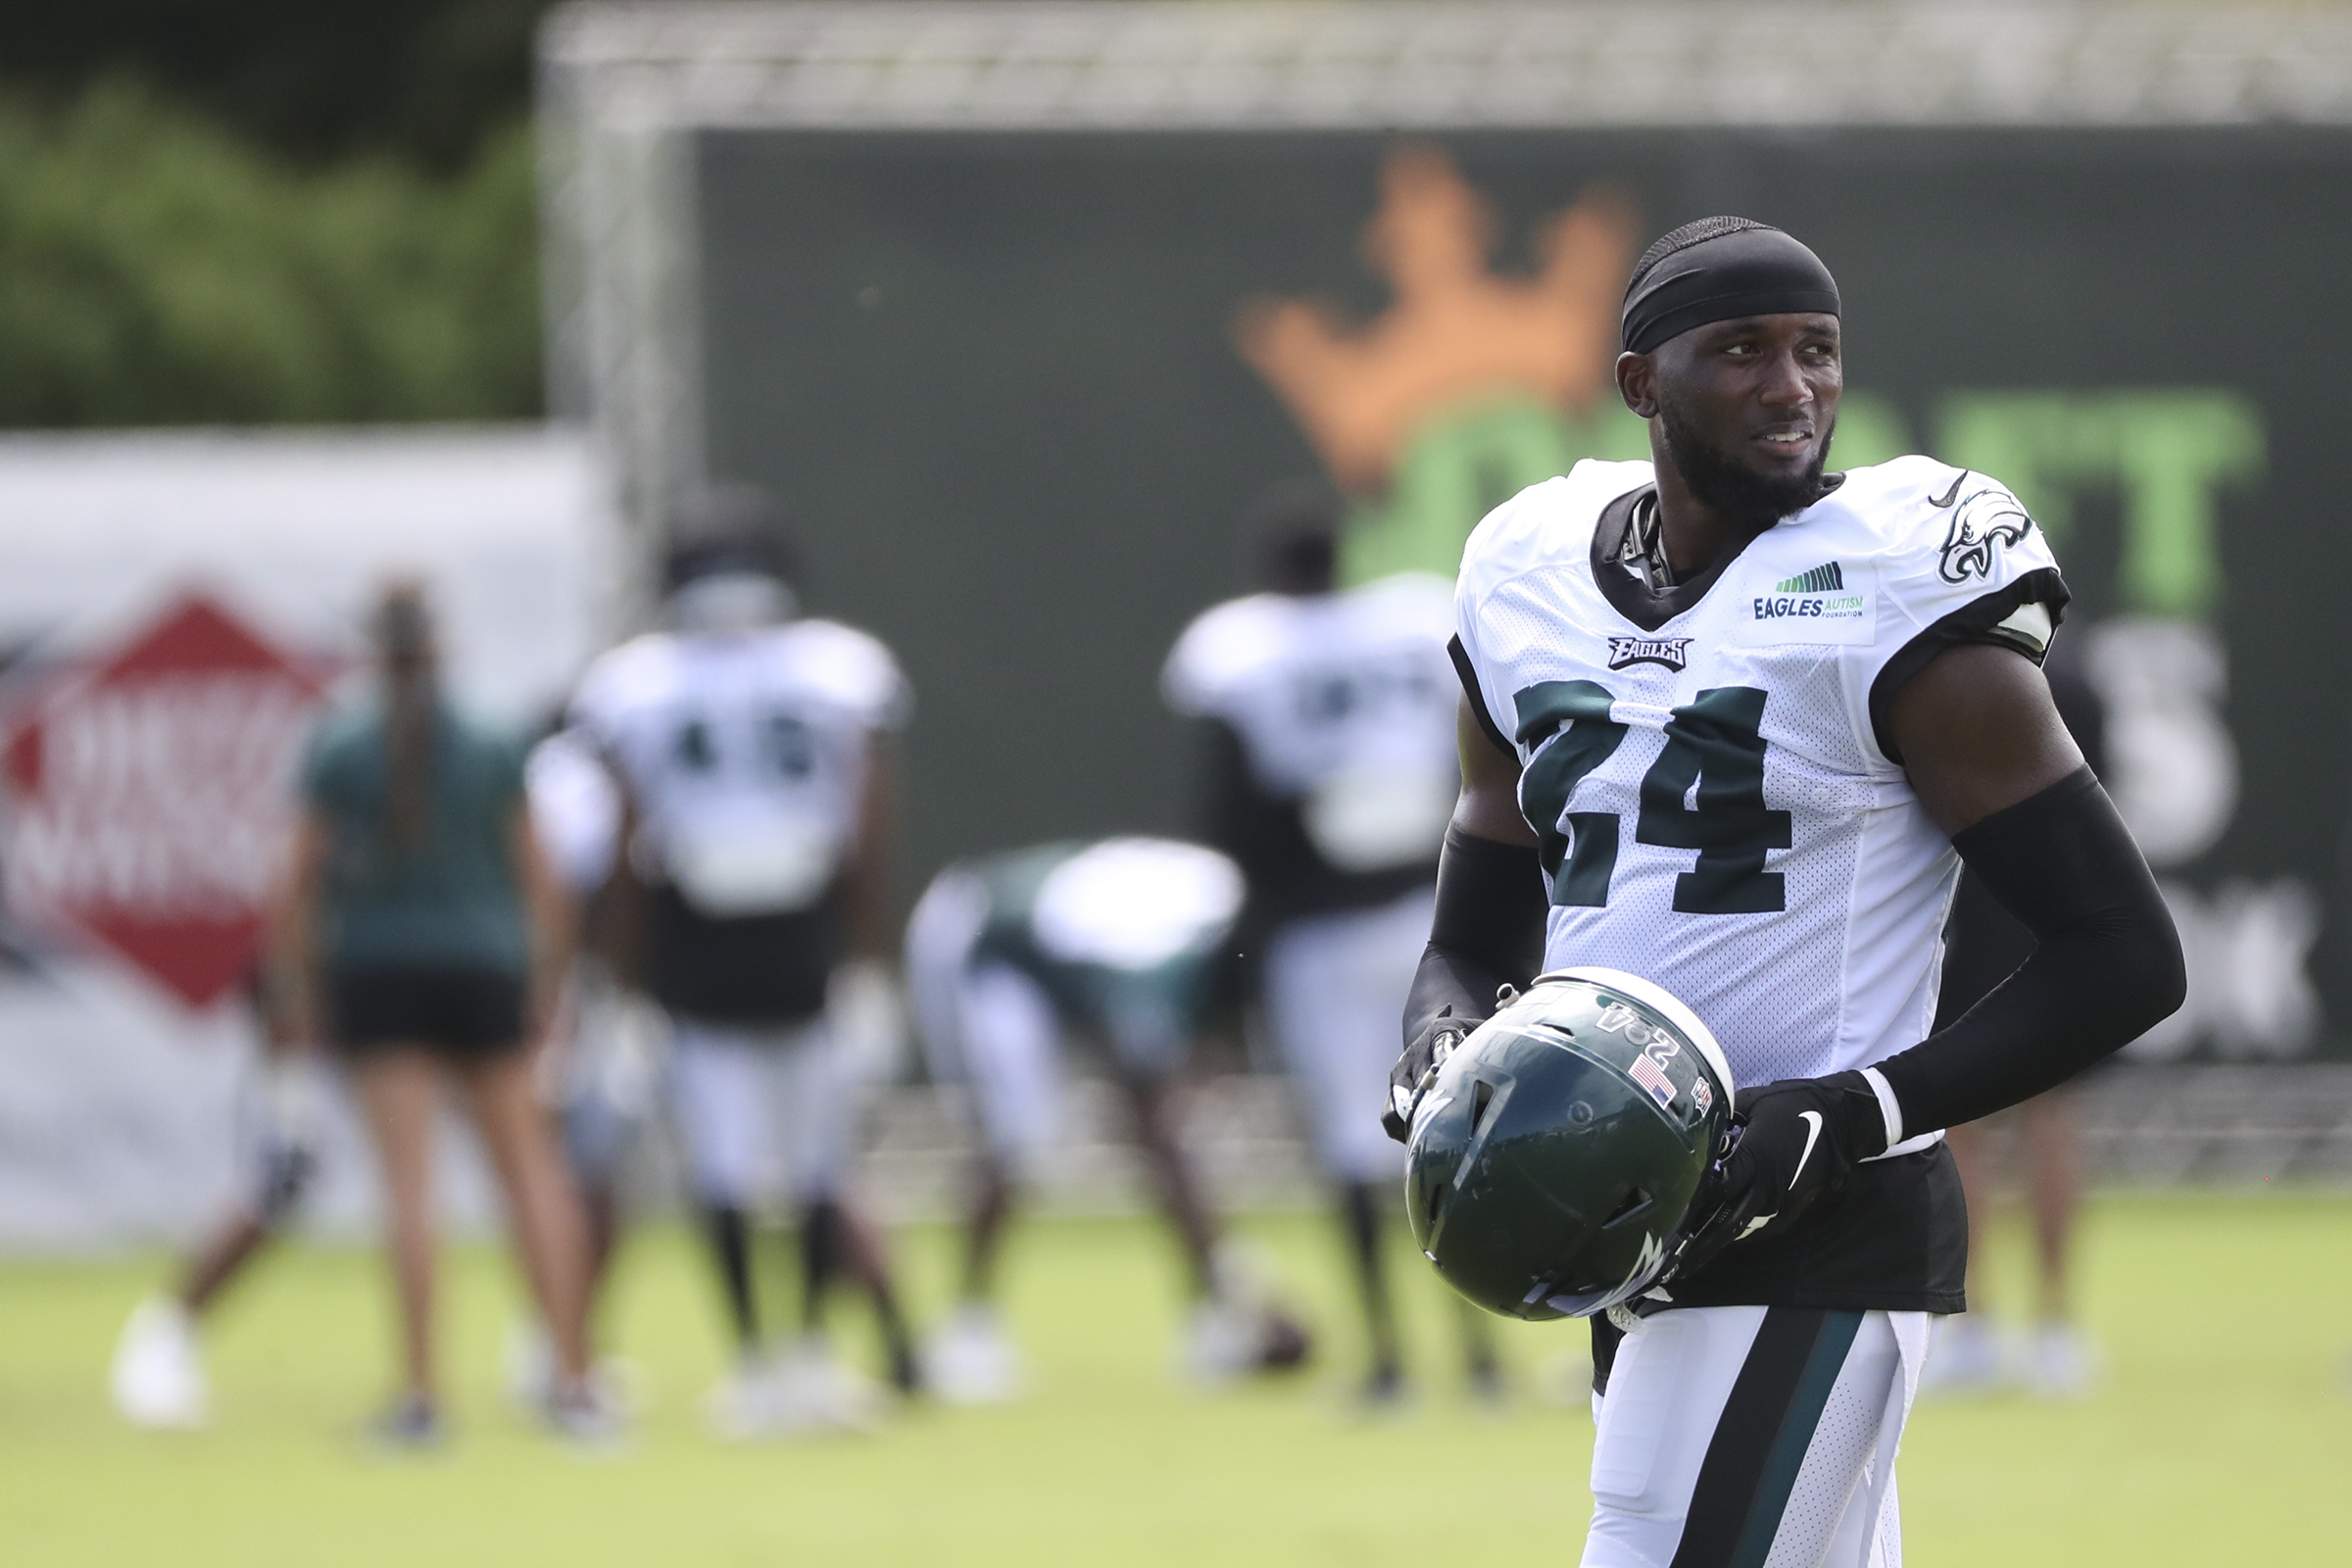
1388,219 -> 2185,1568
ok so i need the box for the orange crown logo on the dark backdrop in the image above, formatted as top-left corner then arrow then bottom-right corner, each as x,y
1235,146 -> 1635,494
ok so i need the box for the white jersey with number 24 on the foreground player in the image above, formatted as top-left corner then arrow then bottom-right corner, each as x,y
1456,456 -> 2065,1109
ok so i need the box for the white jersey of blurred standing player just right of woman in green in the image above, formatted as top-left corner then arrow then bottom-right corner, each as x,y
574,620 -> 907,919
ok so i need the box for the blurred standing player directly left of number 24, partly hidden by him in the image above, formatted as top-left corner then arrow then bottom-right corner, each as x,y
1162,487 -> 1500,1403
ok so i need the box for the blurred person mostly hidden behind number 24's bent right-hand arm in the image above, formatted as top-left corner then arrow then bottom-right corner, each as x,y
1919,644 -> 2107,1398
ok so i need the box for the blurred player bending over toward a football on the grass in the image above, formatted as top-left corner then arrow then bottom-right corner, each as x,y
906,839 -> 1307,1403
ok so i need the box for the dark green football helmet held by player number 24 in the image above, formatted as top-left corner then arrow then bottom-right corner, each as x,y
1404,968 -> 1731,1321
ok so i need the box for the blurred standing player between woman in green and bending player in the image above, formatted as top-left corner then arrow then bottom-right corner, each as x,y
574,489 -> 915,1437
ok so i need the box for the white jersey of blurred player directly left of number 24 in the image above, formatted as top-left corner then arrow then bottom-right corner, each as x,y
1162,571 -> 1458,872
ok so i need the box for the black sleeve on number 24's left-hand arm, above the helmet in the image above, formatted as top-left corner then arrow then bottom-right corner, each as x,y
1404,827 -> 1547,1046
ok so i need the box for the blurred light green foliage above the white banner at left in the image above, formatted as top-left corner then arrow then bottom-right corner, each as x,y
0,82 -> 541,428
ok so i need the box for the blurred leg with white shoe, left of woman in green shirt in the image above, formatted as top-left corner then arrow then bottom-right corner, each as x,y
108,966 -> 322,1429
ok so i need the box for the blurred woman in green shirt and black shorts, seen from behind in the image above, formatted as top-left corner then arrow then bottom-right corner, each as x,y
272,585 -> 616,1446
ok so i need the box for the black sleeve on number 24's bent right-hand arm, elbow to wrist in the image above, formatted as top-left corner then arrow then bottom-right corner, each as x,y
1877,768 -> 2187,1138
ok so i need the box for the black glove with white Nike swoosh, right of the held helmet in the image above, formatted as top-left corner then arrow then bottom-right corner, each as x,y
1675,1072 -> 1886,1274
